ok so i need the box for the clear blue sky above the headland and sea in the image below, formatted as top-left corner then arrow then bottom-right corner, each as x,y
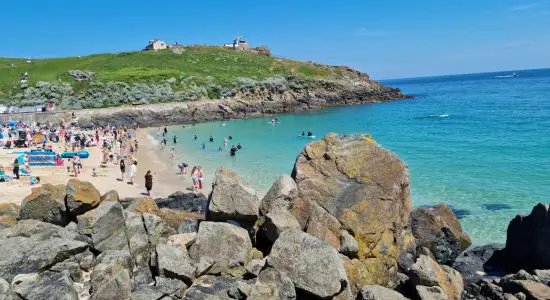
0,0 -> 550,79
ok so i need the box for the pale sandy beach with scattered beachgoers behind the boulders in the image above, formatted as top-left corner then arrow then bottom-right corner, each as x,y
0,129 -> 210,204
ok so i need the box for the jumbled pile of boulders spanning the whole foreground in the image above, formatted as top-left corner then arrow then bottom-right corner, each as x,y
0,134 -> 550,300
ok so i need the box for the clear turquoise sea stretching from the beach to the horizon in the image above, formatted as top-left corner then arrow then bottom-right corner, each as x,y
152,69 -> 550,244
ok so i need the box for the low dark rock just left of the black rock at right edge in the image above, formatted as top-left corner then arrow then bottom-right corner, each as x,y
453,244 -> 504,285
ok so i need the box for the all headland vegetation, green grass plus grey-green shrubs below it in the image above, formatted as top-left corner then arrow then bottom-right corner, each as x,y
0,46 -> 383,109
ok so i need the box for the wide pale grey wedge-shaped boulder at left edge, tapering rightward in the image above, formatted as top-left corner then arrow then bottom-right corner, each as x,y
0,220 -> 88,281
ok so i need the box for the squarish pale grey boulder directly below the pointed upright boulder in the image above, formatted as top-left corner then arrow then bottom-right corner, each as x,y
190,222 -> 252,274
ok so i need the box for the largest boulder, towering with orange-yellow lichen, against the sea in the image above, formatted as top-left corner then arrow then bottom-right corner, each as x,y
292,134 -> 414,290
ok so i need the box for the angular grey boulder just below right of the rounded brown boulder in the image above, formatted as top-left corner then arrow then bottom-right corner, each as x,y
78,202 -> 128,252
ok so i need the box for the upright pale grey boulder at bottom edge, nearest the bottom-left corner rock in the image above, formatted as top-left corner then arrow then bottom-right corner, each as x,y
90,250 -> 133,300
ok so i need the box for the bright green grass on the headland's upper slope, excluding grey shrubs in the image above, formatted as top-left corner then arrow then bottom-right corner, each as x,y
0,47 -> 342,97
